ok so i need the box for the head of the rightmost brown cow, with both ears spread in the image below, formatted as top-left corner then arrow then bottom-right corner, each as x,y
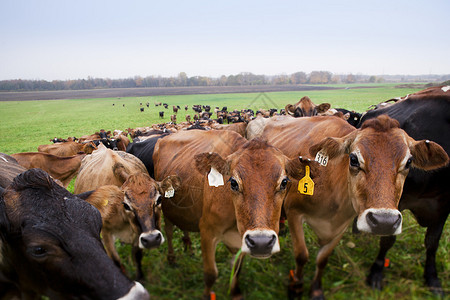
310,115 -> 448,235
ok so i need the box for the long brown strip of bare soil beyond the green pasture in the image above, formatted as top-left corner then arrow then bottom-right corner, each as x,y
0,85 -> 338,101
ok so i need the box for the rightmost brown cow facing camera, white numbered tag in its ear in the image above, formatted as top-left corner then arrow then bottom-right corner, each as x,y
263,116 -> 448,298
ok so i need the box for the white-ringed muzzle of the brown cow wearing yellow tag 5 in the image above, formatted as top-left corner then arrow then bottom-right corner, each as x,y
241,229 -> 280,258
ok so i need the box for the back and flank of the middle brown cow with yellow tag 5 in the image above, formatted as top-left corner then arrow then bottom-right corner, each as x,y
153,130 -> 246,231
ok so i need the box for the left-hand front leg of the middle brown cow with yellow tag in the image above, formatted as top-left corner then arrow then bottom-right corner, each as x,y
200,226 -> 219,299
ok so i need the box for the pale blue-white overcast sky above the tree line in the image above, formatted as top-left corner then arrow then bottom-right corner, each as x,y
0,0 -> 450,80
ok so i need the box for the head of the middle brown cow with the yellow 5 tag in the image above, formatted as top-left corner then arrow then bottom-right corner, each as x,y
195,138 -> 314,258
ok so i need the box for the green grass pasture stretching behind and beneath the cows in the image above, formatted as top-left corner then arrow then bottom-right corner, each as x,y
0,86 -> 450,299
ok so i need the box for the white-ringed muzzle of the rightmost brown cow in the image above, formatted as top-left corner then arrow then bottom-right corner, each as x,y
356,208 -> 402,235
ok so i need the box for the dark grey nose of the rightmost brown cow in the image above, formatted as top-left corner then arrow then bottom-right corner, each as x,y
366,212 -> 402,235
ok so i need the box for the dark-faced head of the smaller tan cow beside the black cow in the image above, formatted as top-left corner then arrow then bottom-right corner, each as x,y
121,173 -> 180,249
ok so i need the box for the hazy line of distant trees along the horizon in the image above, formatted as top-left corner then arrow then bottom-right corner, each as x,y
0,71 -> 446,91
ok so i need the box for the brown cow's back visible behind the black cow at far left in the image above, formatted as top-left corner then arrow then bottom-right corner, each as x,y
11,152 -> 86,188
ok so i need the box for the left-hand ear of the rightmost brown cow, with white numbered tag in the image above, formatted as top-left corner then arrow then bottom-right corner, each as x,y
309,130 -> 356,159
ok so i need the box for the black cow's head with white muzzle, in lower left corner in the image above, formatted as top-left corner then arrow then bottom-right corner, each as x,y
0,169 -> 150,300
